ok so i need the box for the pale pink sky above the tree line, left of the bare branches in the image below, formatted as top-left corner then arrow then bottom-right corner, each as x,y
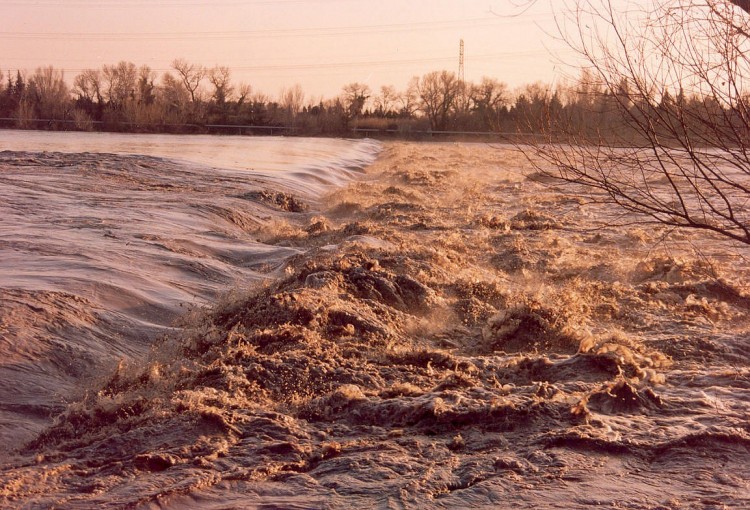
0,0 -> 576,101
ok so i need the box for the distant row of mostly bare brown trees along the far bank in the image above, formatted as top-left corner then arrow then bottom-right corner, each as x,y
0,59 -> 744,142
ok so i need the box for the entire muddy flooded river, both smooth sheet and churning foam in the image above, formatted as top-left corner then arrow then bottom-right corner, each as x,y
0,133 -> 750,508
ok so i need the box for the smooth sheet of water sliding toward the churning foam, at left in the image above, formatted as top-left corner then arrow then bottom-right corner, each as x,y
0,131 -> 379,449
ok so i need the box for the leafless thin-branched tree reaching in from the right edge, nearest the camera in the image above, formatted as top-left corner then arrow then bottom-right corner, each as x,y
527,0 -> 750,244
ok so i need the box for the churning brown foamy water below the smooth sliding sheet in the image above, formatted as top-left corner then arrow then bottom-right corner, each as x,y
0,139 -> 750,509
